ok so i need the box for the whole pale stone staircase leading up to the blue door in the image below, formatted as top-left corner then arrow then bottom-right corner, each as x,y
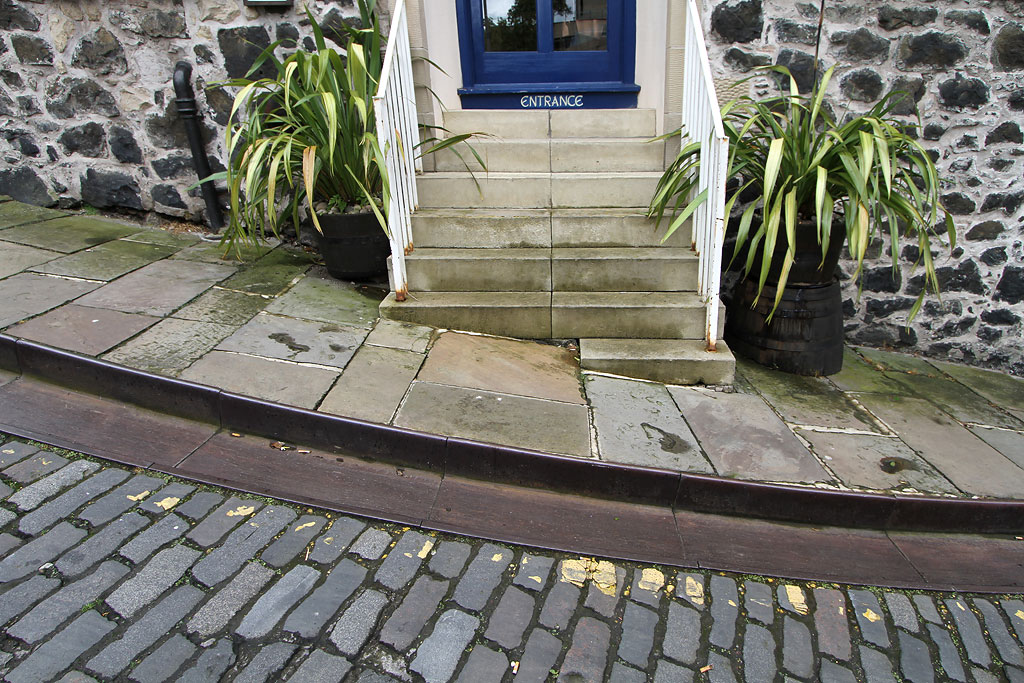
381,110 -> 734,384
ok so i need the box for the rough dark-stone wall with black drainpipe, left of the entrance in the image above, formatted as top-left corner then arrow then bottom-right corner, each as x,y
0,0 -> 366,220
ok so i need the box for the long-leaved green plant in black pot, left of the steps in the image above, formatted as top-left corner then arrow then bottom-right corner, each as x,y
212,0 -> 476,280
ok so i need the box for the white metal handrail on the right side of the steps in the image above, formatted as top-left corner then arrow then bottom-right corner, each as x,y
682,0 -> 729,351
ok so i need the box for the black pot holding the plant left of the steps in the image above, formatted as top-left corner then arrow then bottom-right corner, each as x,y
313,211 -> 391,281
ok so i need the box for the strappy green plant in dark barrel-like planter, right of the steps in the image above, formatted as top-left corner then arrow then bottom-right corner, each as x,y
649,67 -> 956,375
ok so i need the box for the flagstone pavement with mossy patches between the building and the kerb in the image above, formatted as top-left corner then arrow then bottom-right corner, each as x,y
0,202 -> 1024,499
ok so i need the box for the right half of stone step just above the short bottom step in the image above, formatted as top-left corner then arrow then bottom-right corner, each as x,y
551,292 -> 705,339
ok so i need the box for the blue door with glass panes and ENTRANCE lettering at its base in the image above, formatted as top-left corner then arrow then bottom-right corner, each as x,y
457,0 -> 640,109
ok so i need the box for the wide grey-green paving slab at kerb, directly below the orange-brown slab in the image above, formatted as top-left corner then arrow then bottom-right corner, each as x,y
394,381 -> 591,457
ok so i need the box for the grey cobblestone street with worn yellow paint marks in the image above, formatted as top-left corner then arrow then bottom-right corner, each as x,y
0,439 -> 1024,683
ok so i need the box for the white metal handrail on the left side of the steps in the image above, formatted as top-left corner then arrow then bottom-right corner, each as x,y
374,0 -> 423,301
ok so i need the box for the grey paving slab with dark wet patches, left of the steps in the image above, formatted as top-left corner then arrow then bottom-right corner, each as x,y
217,313 -> 367,369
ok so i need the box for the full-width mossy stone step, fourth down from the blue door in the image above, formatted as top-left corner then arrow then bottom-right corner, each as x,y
413,209 -> 690,249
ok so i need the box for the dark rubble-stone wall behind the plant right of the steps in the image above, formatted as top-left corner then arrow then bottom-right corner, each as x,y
705,0 -> 1024,375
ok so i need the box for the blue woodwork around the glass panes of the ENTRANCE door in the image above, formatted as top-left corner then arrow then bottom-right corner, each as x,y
456,0 -> 640,109
